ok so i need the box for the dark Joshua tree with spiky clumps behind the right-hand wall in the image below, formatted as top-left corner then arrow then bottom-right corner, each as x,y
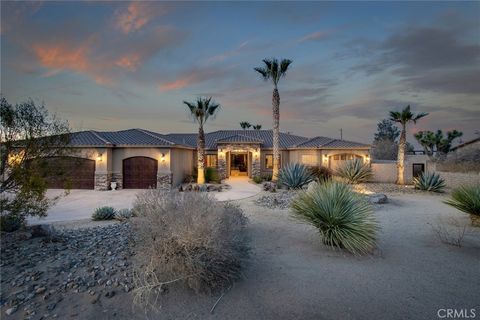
414,130 -> 463,159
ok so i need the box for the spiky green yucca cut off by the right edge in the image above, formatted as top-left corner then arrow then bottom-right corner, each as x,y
443,184 -> 480,227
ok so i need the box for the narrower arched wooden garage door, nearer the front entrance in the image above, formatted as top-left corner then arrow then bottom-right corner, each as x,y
123,157 -> 158,189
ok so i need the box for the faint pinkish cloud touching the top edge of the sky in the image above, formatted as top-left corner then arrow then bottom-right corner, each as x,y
115,1 -> 166,33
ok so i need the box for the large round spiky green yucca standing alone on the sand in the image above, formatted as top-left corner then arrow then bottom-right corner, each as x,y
292,182 -> 379,254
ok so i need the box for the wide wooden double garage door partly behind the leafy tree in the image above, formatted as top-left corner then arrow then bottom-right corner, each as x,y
46,157 -> 95,189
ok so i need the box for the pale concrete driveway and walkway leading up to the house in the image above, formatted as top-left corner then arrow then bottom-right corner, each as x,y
28,177 -> 261,224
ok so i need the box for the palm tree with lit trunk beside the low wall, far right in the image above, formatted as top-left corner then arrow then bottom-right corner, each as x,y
390,105 -> 428,185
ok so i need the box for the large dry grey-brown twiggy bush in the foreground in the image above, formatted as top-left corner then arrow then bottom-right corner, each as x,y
132,190 -> 249,305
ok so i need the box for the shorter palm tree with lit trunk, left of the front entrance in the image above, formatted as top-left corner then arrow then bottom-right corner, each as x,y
183,97 -> 220,184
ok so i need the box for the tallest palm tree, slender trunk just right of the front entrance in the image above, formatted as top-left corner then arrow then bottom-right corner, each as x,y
254,58 -> 293,181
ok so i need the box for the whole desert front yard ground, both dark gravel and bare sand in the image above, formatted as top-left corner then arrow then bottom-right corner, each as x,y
0,193 -> 480,320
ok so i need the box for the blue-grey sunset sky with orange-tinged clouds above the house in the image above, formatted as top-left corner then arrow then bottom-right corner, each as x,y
0,1 -> 480,143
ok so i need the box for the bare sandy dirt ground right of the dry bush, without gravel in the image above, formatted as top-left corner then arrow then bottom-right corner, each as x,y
2,194 -> 480,320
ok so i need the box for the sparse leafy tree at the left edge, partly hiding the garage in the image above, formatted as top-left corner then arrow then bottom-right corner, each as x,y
0,97 -> 71,229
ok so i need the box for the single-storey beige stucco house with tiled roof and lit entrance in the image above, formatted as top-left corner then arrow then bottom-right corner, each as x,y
50,129 -> 370,190
